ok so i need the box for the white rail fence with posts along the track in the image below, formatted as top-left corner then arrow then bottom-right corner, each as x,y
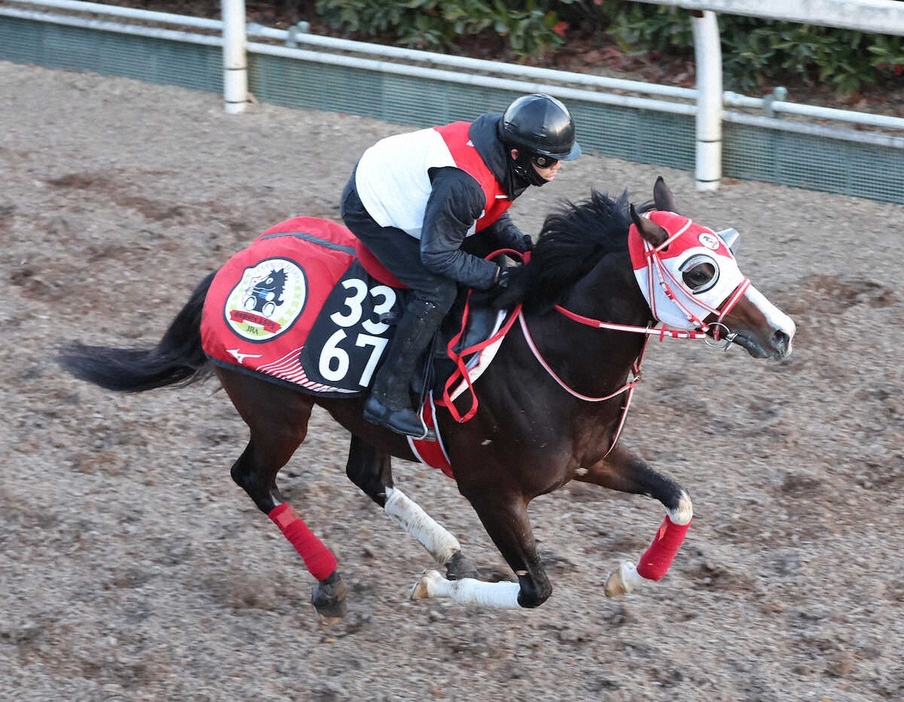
0,0 -> 904,198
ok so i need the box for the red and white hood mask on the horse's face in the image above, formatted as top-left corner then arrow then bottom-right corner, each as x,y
628,210 -> 750,330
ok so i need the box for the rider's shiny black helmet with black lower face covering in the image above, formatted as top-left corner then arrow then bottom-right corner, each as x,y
499,93 -> 581,185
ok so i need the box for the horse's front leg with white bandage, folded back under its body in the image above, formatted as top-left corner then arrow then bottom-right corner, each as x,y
411,485 -> 552,609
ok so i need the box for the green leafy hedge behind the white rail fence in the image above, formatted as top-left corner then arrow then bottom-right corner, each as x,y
314,0 -> 904,94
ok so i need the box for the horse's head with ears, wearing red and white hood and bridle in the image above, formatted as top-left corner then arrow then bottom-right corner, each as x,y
628,178 -> 795,359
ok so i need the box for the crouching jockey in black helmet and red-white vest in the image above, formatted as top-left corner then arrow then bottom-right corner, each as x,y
341,94 -> 581,440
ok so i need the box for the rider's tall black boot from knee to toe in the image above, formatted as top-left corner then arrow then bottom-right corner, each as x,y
364,299 -> 445,441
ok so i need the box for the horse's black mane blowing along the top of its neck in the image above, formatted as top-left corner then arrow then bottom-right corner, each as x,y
494,189 -> 652,309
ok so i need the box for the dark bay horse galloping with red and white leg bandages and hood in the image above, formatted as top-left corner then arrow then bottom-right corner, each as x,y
58,177 -> 795,621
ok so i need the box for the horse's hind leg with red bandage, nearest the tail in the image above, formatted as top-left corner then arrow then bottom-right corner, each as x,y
217,369 -> 346,620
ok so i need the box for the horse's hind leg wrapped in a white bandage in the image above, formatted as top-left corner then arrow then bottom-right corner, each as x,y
346,436 -> 478,580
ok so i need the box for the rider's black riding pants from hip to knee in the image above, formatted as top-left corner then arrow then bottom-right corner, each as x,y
340,172 -> 458,314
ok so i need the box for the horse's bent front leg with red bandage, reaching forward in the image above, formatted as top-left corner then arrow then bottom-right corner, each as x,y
575,446 -> 694,597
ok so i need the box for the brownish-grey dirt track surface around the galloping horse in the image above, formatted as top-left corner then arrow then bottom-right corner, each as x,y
0,63 -> 904,702
